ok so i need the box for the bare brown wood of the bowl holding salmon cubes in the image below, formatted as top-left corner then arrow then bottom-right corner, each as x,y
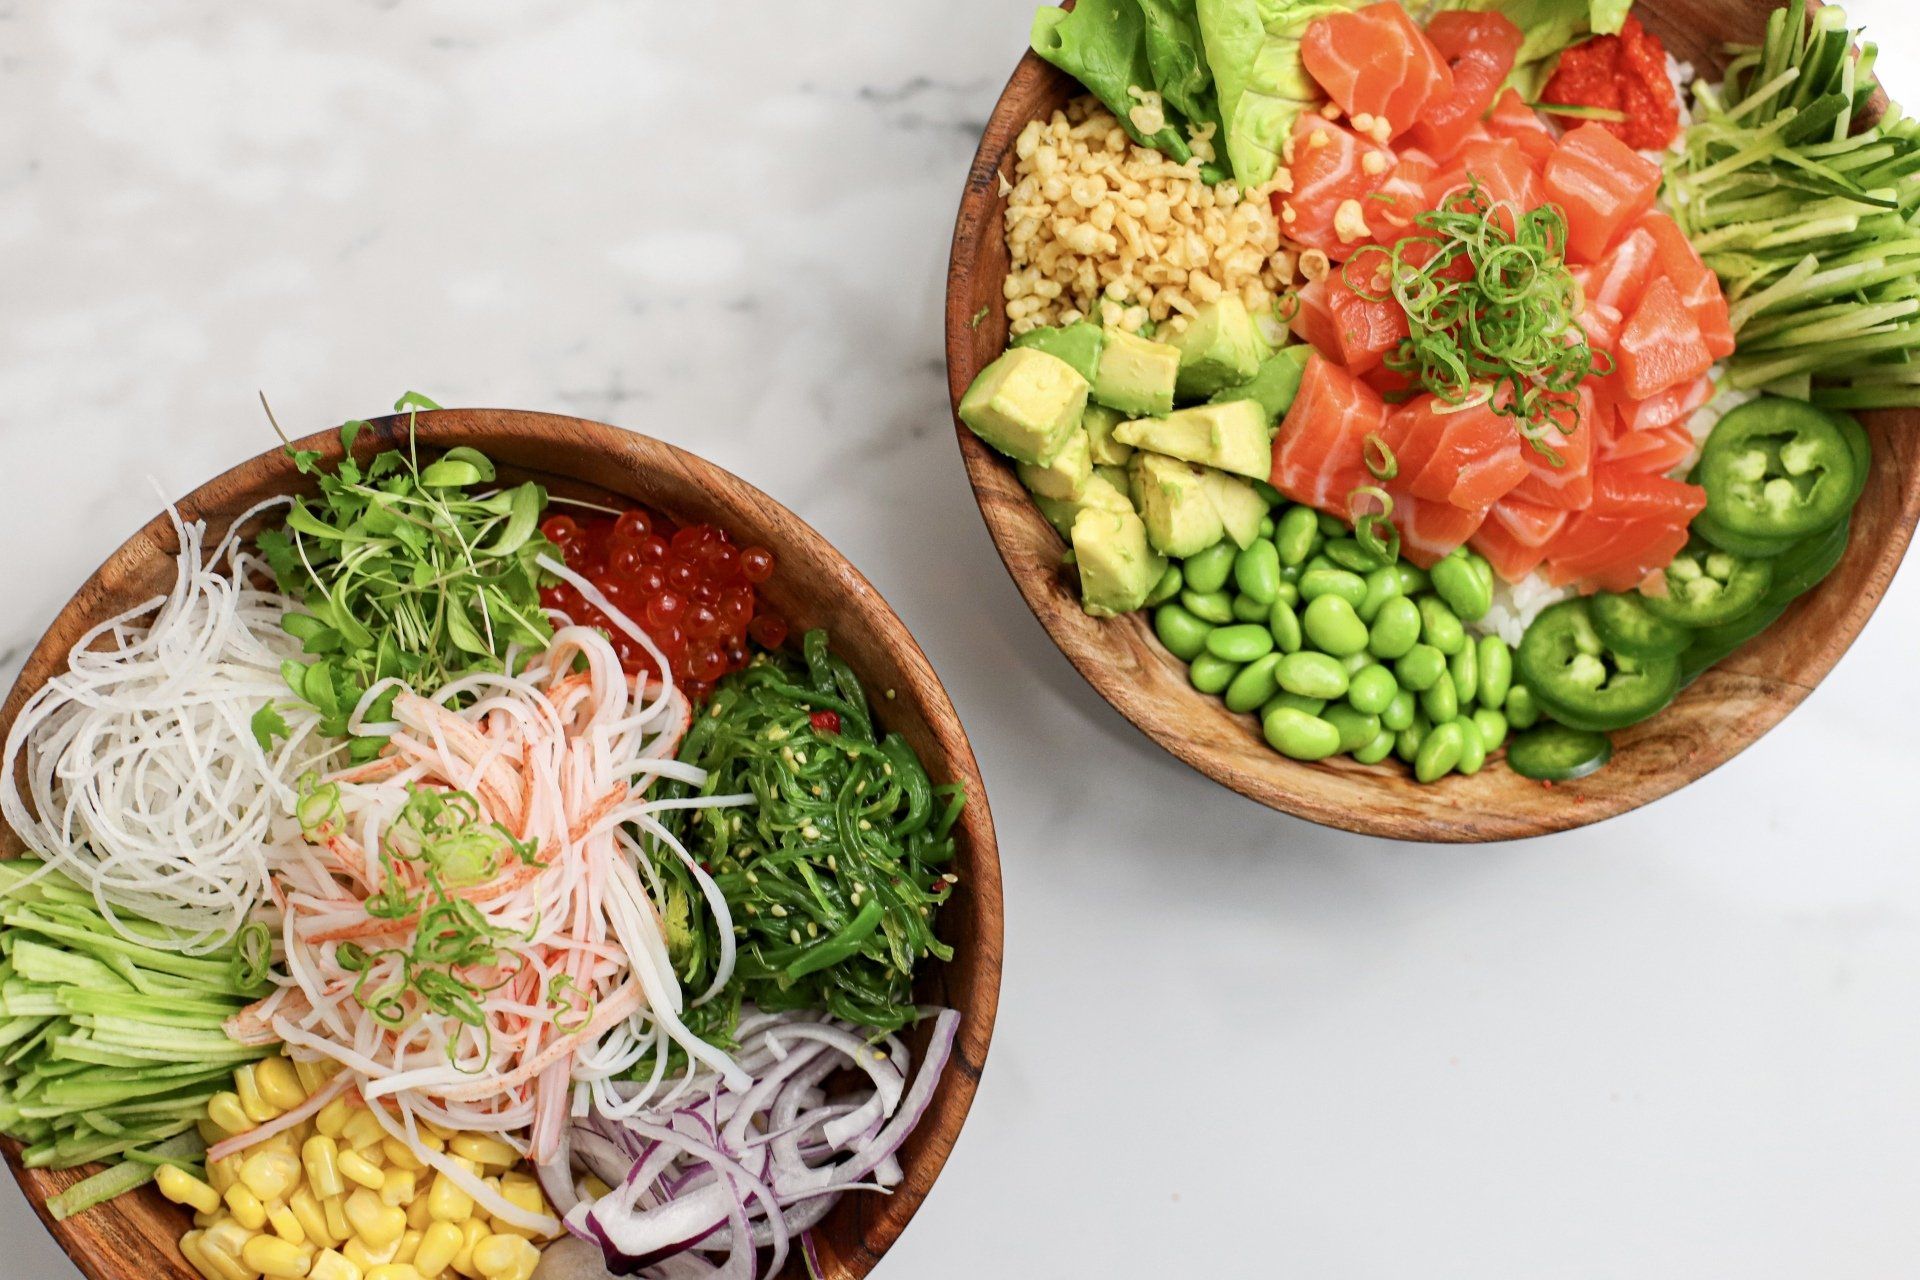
947,0 -> 1920,841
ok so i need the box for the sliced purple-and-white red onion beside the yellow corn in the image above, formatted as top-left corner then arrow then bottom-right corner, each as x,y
566,1009 -> 960,1280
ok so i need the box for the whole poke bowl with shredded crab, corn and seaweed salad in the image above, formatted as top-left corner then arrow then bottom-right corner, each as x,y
0,401 -> 1000,1280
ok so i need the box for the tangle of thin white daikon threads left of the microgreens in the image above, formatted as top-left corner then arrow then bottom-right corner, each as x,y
0,499 -> 338,952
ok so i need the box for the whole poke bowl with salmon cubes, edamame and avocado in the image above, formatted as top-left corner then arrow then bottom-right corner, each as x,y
947,0 -> 1920,842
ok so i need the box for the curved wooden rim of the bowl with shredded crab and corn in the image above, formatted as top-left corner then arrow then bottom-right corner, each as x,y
0,409 -> 1004,1280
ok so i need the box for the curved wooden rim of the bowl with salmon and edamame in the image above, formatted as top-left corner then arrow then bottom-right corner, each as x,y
947,17 -> 1920,842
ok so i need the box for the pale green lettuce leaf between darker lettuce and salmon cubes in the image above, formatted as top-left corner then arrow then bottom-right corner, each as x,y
1194,0 -> 1363,186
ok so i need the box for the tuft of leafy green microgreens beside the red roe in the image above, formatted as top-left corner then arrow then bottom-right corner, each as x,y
253,391 -> 557,760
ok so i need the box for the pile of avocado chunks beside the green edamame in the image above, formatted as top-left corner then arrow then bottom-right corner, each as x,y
960,296 -> 1309,618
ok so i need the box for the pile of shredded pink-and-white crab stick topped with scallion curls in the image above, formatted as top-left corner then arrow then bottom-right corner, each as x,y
228,618 -> 751,1174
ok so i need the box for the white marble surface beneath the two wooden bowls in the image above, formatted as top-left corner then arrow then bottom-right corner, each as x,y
0,0 -> 1920,1280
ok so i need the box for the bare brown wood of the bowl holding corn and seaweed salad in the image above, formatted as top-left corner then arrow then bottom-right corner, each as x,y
0,409 -> 1002,1280
